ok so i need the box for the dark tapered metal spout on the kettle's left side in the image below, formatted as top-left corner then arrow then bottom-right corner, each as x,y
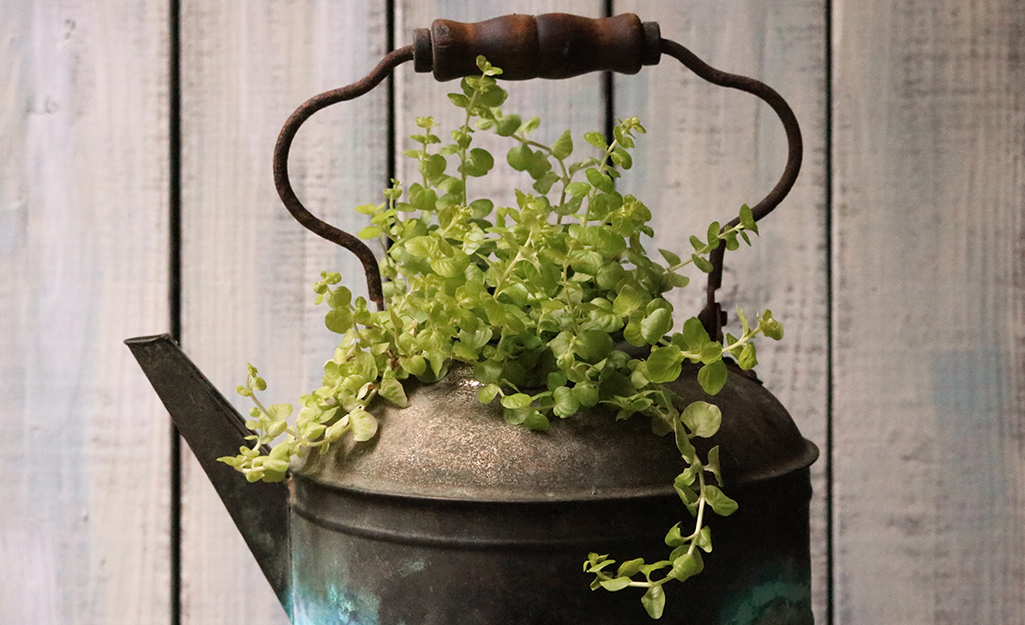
125,334 -> 289,610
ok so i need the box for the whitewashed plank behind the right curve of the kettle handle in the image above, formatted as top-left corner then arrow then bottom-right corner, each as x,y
615,0 -> 828,622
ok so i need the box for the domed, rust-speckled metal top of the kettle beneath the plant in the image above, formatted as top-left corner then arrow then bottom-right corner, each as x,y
301,358 -> 818,501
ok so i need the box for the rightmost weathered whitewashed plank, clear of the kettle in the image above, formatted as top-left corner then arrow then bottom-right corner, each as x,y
833,0 -> 1025,625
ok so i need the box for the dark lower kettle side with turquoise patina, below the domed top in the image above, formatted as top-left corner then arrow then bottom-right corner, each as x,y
291,465 -> 812,625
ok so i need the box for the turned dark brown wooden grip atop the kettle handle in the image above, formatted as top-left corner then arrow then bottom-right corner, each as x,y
413,13 -> 661,81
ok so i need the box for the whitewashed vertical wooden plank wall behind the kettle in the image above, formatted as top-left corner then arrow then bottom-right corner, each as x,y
0,0 -> 1025,625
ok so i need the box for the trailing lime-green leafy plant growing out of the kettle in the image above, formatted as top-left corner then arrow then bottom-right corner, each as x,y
220,57 -> 783,619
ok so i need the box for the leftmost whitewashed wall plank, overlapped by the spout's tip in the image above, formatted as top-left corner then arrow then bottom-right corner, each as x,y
0,0 -> 170,625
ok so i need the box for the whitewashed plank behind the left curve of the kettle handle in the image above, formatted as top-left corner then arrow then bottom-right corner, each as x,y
181,0 -> 387,625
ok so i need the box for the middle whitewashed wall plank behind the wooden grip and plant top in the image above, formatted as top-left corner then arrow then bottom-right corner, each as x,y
396,0 -> 605,206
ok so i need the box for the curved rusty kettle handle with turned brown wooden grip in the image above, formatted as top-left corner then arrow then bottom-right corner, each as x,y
274,13 -> 804,338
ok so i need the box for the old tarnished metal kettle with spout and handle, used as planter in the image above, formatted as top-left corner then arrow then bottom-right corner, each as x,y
126,13 -> 818,625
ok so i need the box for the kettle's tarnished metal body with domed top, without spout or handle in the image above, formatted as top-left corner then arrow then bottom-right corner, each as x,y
291,358 -> 818,625
